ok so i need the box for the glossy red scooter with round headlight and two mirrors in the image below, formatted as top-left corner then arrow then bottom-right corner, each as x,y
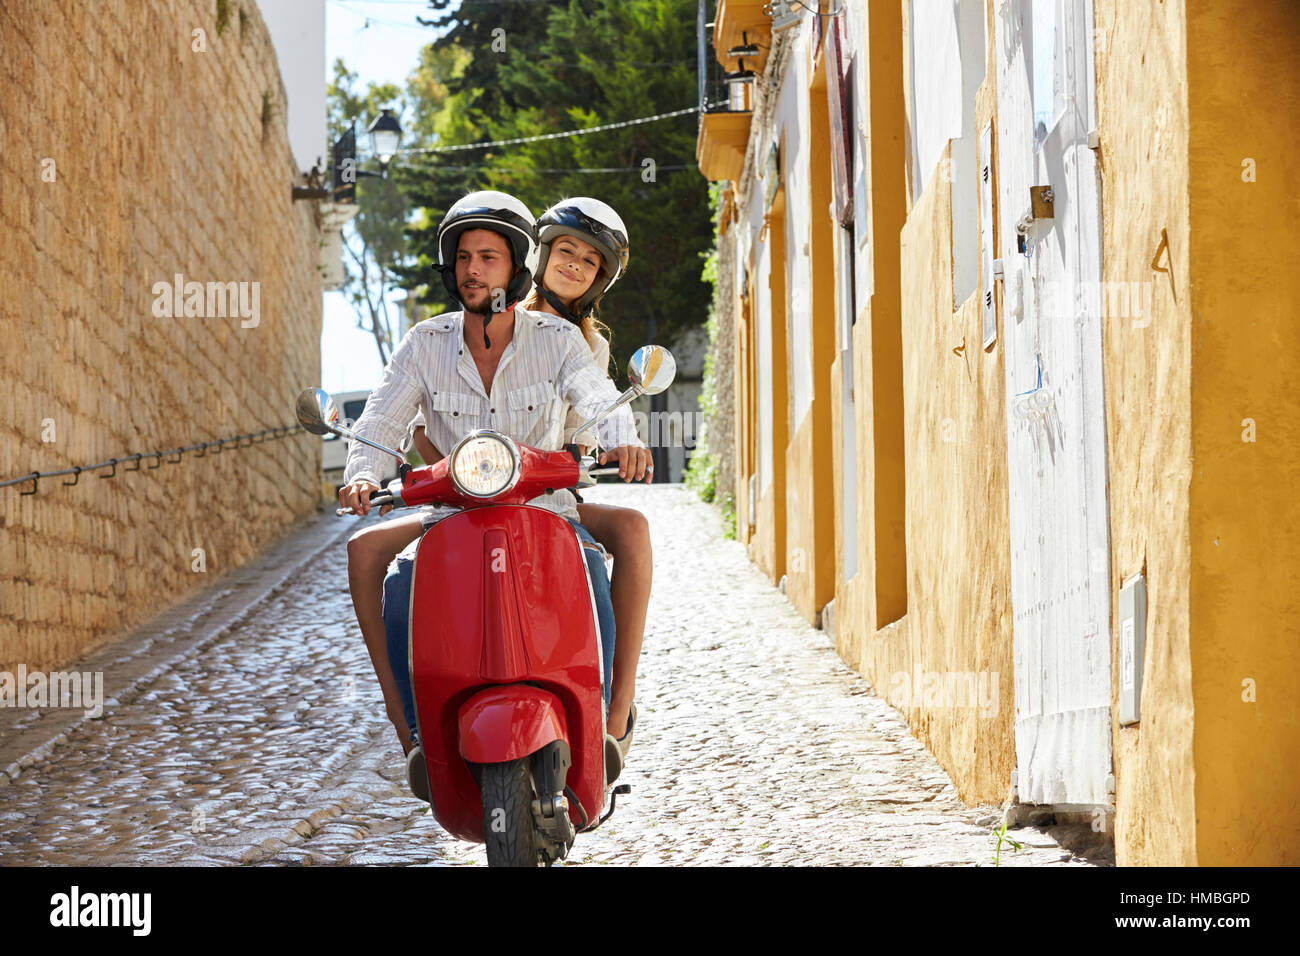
298,346 -> 676,866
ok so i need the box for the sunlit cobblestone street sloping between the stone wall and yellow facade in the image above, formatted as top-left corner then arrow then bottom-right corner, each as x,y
0,485 -> 1086,866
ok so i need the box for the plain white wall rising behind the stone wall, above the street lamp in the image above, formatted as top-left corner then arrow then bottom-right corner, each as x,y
259,0 -> 329,170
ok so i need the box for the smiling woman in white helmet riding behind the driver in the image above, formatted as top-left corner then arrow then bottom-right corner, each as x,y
347,198 -> 651,756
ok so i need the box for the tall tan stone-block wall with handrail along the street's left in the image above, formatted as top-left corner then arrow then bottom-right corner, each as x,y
0,0 -> 321,671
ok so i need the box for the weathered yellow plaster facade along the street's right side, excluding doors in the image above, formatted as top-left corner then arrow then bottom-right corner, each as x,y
722,0 -> 1300,865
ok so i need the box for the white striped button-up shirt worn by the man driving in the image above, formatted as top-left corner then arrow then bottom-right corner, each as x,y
343,307 -> 642,520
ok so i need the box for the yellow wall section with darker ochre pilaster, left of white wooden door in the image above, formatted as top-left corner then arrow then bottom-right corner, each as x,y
832,5 -> 1015,801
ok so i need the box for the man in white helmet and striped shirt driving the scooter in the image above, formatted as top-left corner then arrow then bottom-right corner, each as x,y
339,191 -> 650,799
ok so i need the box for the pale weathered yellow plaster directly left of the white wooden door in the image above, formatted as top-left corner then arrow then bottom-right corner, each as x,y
894,147 -> 1015,801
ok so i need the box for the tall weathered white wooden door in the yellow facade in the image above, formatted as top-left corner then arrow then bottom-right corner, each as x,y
996,0 -> 1112,805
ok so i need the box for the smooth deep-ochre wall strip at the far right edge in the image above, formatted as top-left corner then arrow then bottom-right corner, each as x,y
1190,0 -> 1300,866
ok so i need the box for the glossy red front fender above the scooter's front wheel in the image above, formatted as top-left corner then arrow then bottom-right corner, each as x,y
458,684 -> 569,763
